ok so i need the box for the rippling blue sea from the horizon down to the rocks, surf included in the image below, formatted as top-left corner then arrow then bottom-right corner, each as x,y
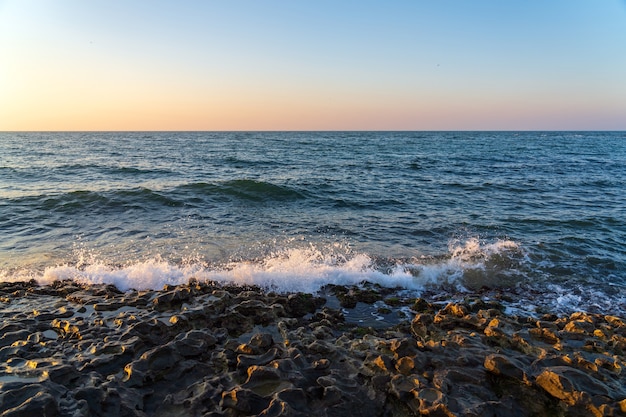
0,132 -> 626,315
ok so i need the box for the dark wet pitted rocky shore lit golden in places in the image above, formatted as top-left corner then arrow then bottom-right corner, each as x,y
0,281 -> 626,417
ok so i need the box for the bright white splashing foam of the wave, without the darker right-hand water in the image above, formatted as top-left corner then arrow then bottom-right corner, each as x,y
39,239 -> 519,293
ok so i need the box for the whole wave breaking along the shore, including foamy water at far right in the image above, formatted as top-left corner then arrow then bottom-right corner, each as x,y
0,238 -> 624,314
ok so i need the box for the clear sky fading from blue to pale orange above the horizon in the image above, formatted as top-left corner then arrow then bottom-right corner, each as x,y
0,0 -> 626,131
